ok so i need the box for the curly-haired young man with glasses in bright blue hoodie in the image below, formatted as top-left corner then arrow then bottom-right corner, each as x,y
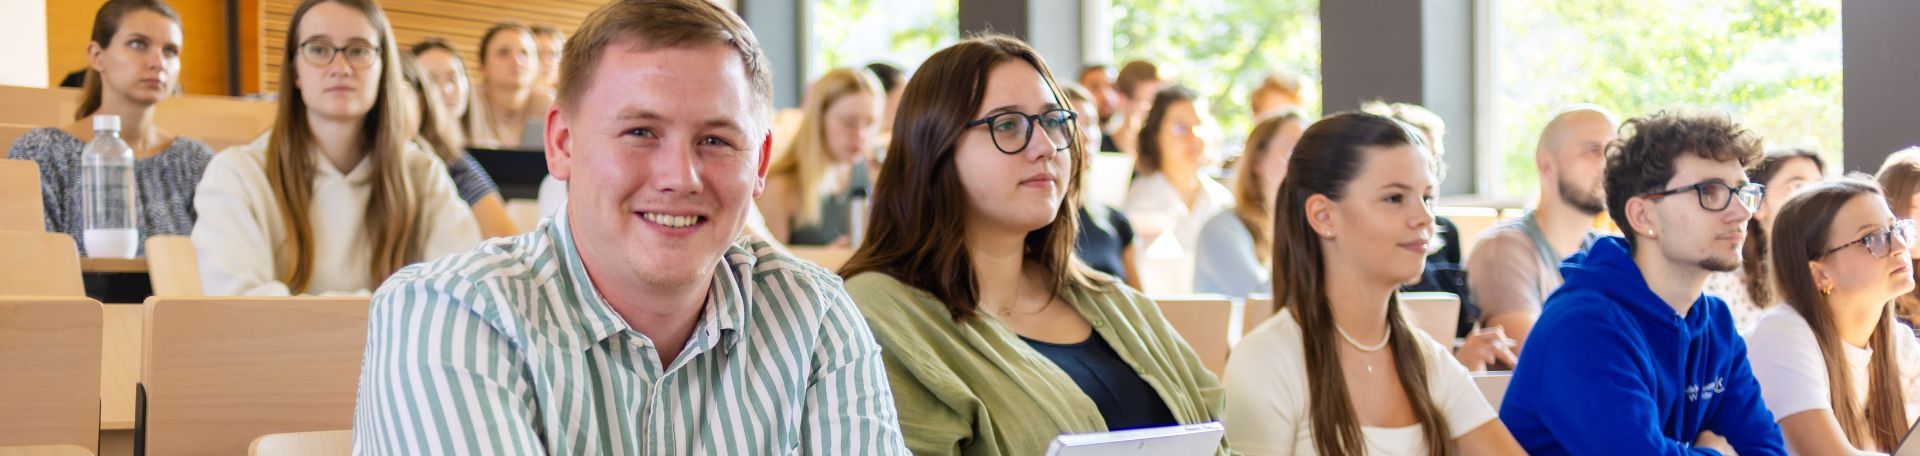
1500,111 -> 1786,456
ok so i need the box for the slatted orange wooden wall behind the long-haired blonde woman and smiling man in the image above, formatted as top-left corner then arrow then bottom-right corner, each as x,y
242,0 -> 605,92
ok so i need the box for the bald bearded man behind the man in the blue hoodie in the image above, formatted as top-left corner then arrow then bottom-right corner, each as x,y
1467,105 -> 1619,349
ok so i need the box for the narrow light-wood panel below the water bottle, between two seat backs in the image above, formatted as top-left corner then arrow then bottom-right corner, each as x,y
100,305 -> 146,433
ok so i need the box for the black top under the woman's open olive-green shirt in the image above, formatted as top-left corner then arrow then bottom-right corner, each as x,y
1020,333 -> 1179,431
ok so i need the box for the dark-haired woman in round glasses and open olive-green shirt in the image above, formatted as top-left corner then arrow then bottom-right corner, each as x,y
841,34 -> 1221,454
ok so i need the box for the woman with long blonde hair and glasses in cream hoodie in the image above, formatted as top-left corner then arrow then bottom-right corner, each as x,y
194,0 -> 480,295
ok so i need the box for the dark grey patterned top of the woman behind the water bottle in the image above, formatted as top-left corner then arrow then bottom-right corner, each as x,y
8,128 -> 213,255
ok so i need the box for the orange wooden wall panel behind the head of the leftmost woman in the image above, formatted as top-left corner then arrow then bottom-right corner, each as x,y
46,0 -> 230,96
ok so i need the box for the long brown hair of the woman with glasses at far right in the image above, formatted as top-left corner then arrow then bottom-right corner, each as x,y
1772,180 -> 1907,450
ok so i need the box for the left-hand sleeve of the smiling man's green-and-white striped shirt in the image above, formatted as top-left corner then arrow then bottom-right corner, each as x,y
353,264 -> 545,454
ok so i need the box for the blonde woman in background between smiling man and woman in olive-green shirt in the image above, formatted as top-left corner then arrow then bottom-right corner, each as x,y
758,69 -> 887,245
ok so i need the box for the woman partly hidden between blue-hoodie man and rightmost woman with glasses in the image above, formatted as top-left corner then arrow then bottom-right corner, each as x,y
1705,148 -> 1826,331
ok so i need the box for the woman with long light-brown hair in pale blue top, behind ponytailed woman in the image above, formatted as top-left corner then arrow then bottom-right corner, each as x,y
1194,111 -> 1308,295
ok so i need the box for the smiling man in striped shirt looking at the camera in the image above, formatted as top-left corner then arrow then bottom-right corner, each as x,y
353,0 -> 906,454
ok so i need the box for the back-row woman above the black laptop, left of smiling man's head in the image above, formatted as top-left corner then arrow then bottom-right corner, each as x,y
467,23 -> 553,149
